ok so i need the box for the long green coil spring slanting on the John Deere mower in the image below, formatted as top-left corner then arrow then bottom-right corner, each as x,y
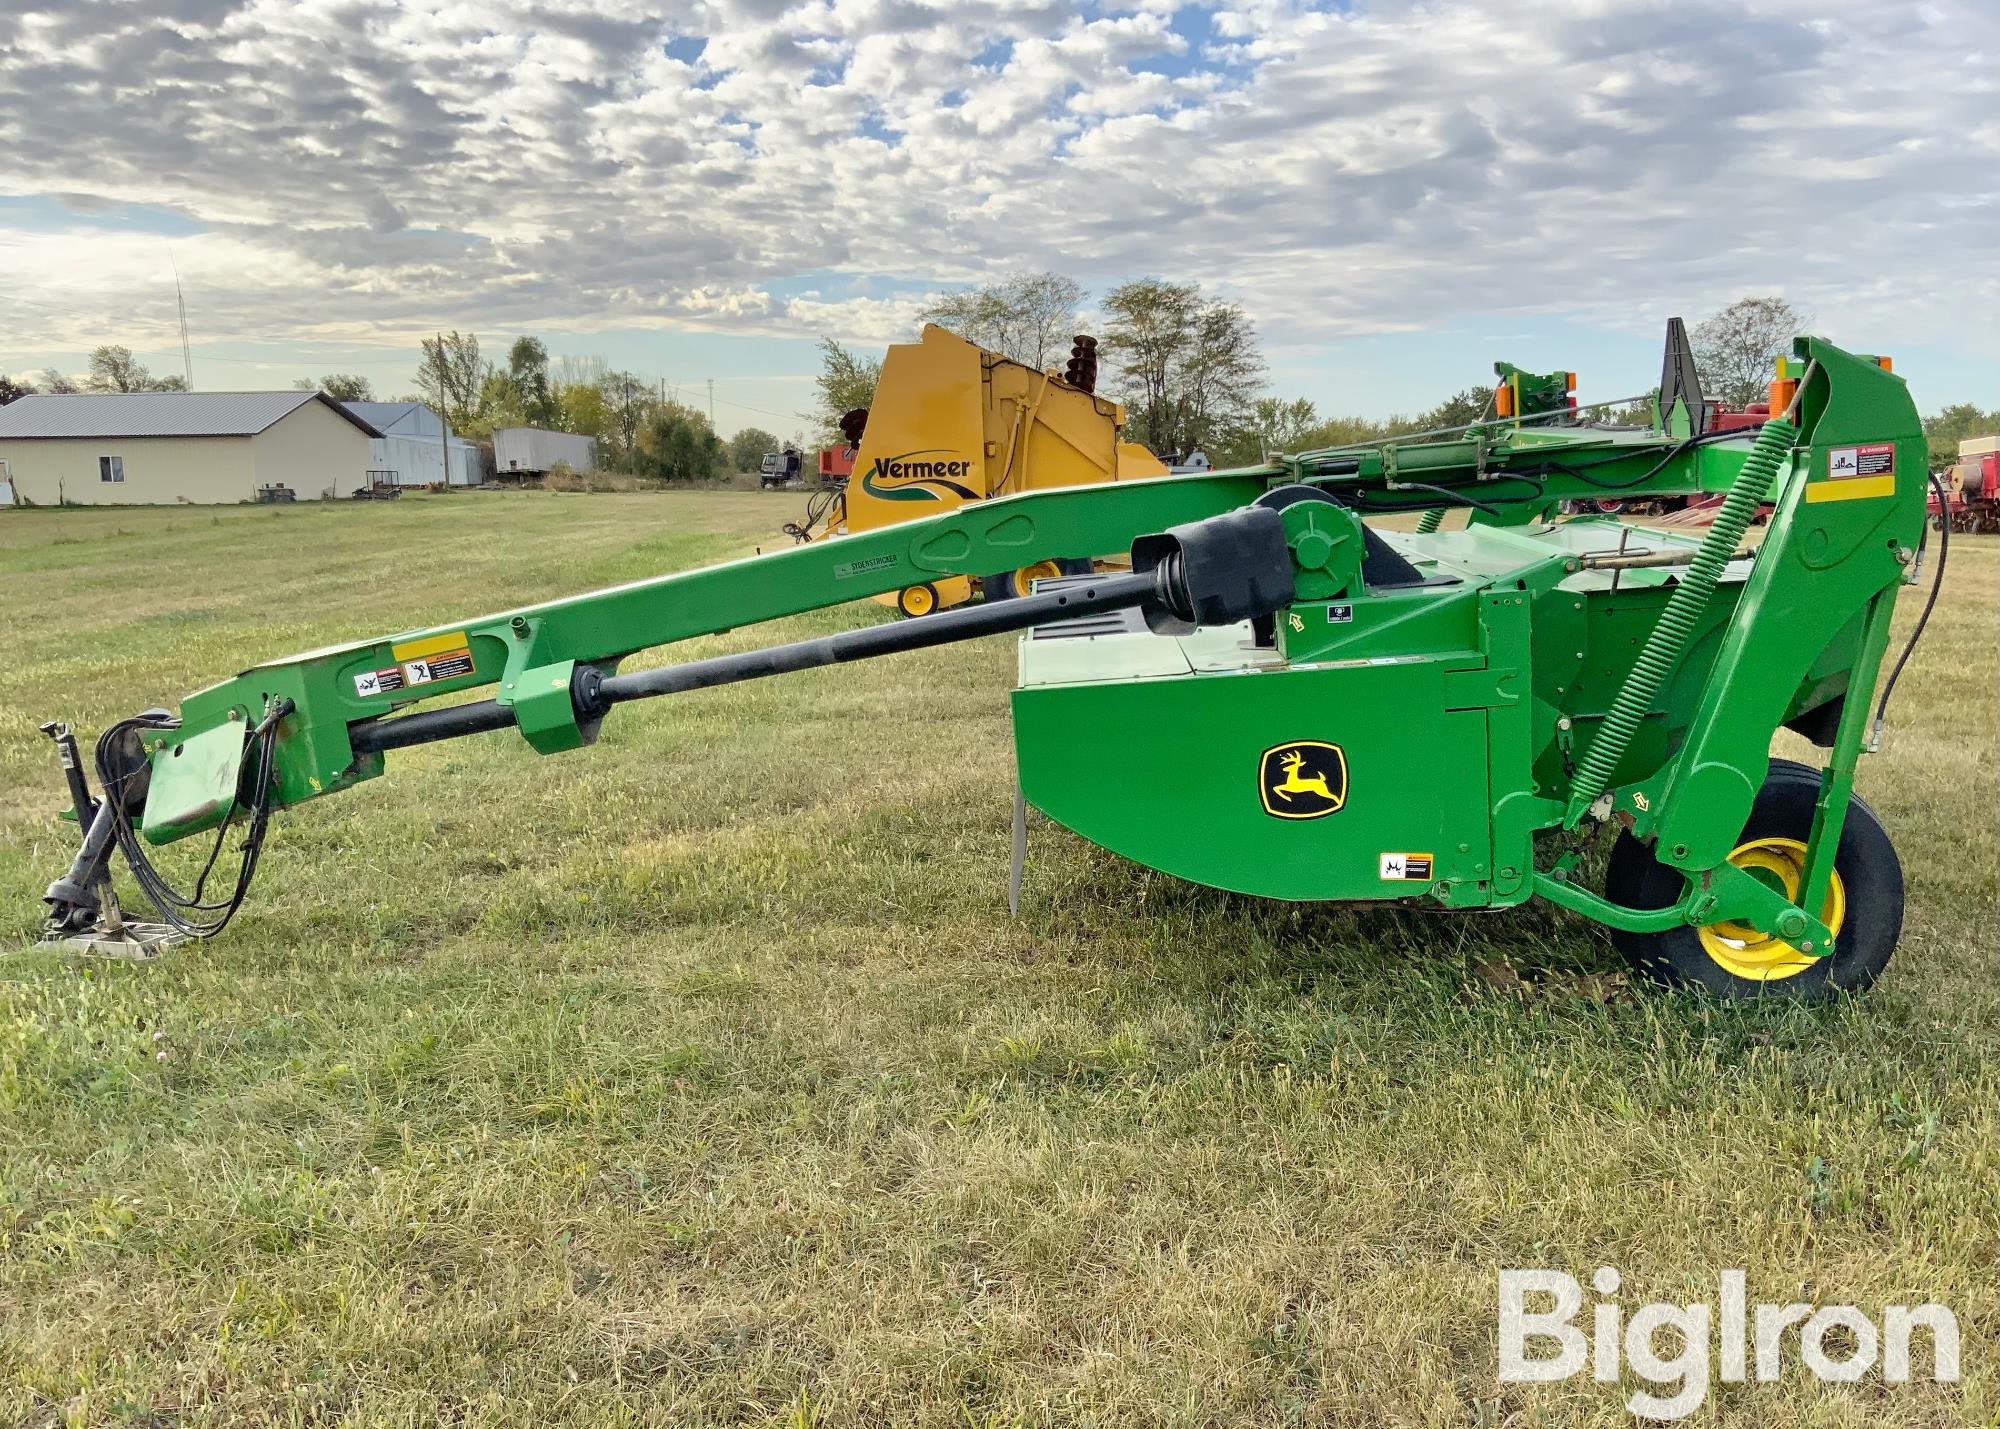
1564,416 -> 1798,827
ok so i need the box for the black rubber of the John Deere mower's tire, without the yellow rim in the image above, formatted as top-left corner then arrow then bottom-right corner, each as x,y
1604,759 -> 1904,1001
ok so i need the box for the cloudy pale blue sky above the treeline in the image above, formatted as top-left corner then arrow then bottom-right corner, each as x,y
0,0 -> 2000,430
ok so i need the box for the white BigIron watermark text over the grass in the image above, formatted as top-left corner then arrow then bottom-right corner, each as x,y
1500,1265 -> 1958,1419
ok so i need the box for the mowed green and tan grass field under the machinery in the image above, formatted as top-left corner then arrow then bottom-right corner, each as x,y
0,484 -> 2000,1429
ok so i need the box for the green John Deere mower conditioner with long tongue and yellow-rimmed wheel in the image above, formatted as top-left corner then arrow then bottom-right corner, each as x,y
35,324 -> 1926,997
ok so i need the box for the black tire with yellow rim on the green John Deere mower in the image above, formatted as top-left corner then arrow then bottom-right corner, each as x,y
1604,759 -> 1902,1001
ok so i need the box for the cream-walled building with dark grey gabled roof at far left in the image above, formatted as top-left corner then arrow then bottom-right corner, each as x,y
0,390 -> 380,506
